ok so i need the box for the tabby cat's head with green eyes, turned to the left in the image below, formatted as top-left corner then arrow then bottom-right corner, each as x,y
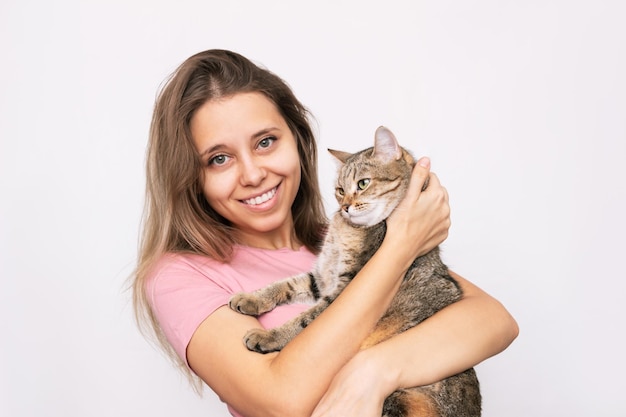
328,126 -> 415,226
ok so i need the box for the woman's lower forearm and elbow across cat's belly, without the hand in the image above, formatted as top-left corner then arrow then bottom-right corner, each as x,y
382,272 -> 519,392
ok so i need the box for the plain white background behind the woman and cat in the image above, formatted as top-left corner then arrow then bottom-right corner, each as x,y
0,0 -> 626,417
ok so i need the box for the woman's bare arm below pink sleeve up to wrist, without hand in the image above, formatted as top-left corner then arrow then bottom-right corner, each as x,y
187,240 -> 403,417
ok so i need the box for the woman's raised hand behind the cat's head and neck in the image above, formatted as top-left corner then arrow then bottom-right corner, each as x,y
385,158 -> 450,266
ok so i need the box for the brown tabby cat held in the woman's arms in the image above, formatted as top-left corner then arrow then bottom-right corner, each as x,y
230,126 -> 481,417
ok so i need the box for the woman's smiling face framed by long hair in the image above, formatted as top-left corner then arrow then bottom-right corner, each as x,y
190,93 -> 301,247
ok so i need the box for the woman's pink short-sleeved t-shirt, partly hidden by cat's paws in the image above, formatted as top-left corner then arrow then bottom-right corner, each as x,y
146,245 -> 316,363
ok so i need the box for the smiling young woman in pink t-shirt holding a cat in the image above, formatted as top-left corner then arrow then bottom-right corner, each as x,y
134,50 -> 518,417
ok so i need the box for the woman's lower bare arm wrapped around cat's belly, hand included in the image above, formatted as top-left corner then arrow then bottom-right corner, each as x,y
312,272 -> 519,417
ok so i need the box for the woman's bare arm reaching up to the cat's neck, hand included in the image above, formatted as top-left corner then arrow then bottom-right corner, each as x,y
187,160 -> 449,417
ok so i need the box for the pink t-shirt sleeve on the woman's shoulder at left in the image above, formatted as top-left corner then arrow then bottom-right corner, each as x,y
146,255 -> 232,363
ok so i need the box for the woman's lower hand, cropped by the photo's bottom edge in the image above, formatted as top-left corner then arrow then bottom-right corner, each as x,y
311,351 -> 393,417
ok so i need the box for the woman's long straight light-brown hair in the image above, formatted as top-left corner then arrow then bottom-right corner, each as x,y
132,50 -> 326,388
